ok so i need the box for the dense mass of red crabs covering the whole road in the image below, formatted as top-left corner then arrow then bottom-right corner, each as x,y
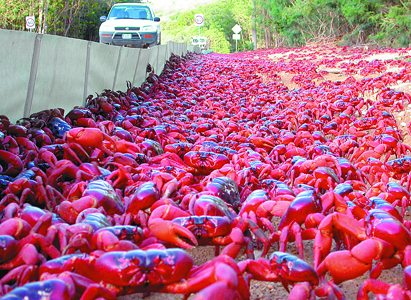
0,47 -> 411,299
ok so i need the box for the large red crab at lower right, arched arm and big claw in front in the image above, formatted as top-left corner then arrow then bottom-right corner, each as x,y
314,209 -> 411,284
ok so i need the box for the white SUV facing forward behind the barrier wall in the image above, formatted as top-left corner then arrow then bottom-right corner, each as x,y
99,3 -> 161,48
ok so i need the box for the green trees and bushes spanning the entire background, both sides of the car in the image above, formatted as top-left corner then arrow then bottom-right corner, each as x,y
0,0 -> 411,53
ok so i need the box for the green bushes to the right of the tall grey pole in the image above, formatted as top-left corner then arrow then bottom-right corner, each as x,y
248,0 -> 411,47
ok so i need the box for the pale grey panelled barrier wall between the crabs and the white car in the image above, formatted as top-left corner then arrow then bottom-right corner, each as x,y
0,29 -> 188,123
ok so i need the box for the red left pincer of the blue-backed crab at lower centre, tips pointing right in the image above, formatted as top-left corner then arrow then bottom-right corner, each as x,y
149,219 -> 198,249
